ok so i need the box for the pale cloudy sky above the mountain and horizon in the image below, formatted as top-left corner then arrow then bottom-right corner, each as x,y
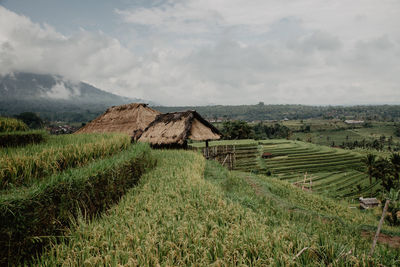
0,0 -> 400,106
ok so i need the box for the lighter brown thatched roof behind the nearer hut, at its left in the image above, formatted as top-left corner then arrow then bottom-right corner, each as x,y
76,103 -> 160,136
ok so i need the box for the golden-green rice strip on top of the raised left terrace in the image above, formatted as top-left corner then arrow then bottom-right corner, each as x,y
0,134 -> 130,189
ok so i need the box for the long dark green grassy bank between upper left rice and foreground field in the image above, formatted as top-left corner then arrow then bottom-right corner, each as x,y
0,144 -> 154,264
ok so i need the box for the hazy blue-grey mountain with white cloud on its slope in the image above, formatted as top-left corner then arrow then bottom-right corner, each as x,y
0,72 -> 153,122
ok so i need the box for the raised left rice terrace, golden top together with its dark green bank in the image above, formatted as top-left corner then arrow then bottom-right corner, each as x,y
0,134 -> 154,265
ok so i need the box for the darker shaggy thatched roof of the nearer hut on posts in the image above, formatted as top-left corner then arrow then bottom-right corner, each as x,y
136,110 -> 222,146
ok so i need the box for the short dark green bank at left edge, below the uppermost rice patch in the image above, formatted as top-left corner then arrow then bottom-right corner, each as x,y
0,131 -> 47,147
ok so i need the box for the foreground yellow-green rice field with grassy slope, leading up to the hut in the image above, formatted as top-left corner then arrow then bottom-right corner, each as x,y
35,151 -> 400,266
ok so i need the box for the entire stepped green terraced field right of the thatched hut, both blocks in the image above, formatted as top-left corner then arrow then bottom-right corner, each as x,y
192,139 -> 381,199
